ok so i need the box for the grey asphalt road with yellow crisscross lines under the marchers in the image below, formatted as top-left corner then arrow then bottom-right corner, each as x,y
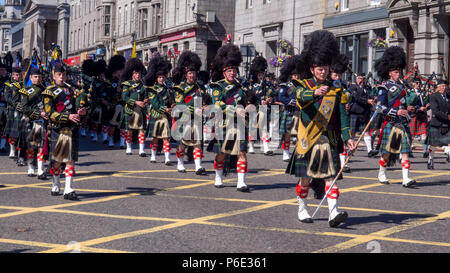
0,135 -> 450,253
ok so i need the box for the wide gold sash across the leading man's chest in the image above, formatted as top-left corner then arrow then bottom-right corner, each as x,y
296,80 -> 341,155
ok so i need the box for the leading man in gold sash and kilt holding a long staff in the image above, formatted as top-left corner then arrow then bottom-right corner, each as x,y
286,30 -> 355,227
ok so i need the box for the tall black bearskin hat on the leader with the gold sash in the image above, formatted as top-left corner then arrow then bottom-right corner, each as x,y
297,30 -> 339,77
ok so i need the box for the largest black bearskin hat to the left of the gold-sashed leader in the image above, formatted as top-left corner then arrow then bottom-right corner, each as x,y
211,44 -> 242,81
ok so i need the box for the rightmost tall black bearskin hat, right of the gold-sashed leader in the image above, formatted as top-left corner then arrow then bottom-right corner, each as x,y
375,46 -> 406,80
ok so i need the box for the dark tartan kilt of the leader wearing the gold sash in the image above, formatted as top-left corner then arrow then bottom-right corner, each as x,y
286,140 -> 341,179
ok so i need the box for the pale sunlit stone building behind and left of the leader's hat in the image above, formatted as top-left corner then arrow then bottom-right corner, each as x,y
234,0 -> 326,76
